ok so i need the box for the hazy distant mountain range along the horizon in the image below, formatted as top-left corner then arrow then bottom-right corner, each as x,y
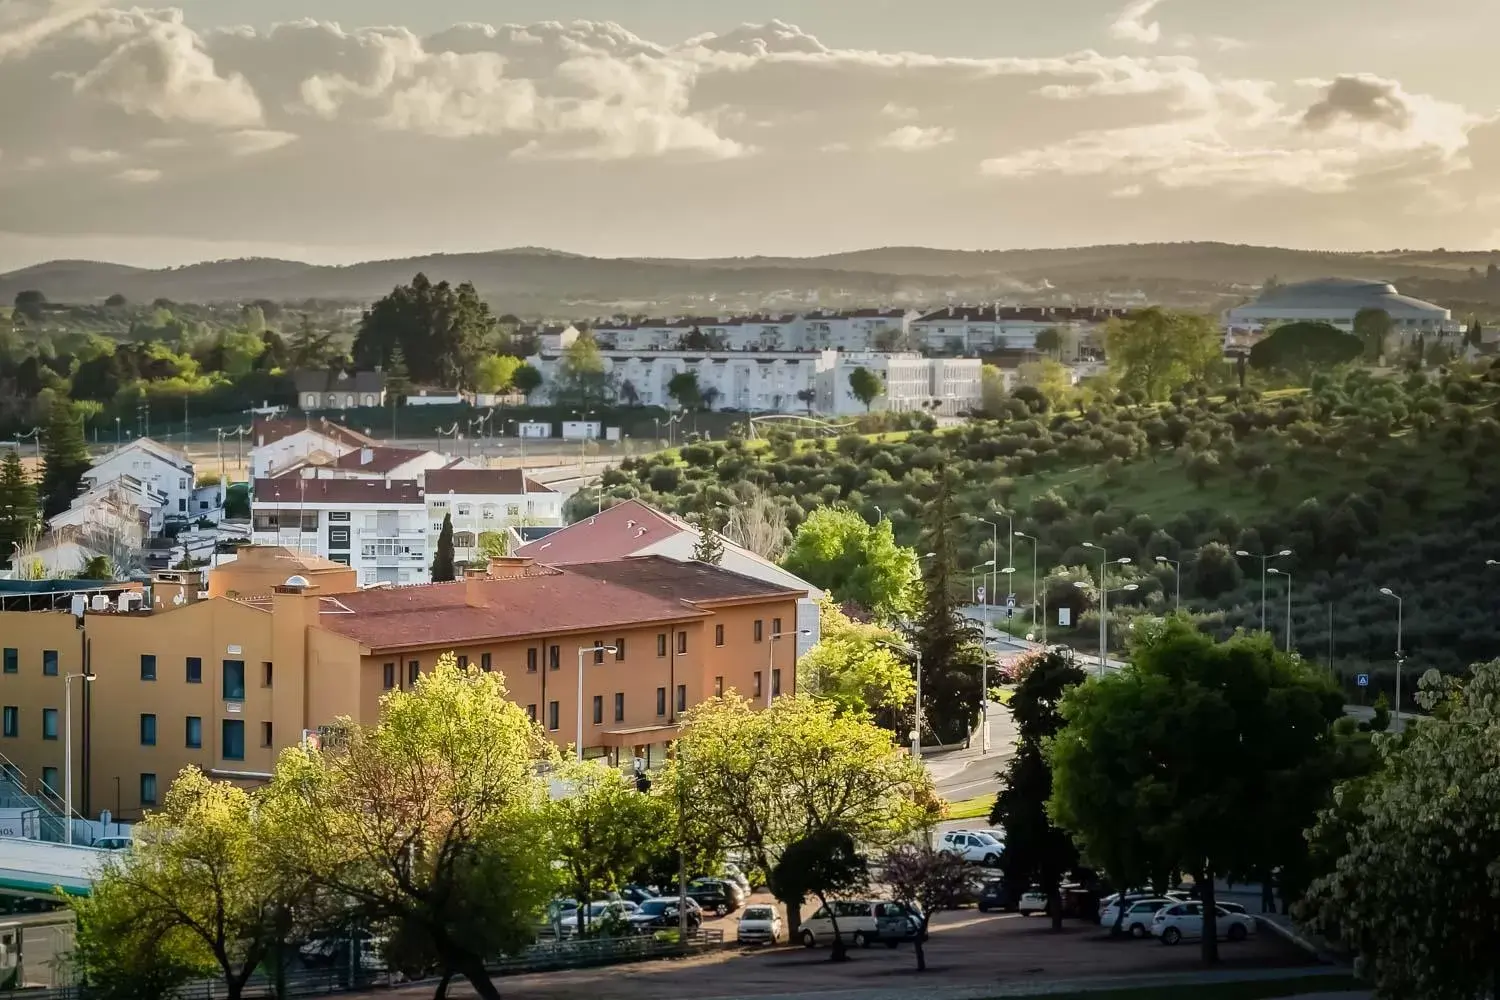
0,243 -> 1500,315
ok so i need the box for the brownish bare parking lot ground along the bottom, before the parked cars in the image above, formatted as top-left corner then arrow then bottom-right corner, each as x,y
363,910 -> 1314,1000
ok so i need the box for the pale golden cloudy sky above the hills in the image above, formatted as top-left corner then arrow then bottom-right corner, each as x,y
0,0 -> 1500,270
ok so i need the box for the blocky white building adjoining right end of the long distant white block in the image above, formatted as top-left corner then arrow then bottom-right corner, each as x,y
818,354 -> 984,417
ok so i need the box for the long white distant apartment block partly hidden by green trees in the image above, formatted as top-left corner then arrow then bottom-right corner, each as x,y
528,349 -> 837,412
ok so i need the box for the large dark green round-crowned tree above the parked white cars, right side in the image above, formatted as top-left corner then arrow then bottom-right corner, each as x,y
1049,618 -> 1344,963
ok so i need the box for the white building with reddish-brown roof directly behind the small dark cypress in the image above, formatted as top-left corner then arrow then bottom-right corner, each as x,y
425,468 -> 563,564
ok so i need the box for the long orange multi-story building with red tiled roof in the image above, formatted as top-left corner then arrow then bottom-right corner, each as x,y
0,552 -> 806,820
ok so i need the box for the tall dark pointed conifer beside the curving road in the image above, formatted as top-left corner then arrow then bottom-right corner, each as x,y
914,474 -> 986,744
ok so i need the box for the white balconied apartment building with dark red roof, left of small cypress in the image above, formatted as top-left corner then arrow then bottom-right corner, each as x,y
251,477 -> 437,586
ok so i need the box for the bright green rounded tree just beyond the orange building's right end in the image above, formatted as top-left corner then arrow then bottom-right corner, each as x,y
782,507 -> 917,618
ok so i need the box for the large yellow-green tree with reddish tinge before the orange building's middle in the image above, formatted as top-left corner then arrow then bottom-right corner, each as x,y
263,654 -> 558,1000
